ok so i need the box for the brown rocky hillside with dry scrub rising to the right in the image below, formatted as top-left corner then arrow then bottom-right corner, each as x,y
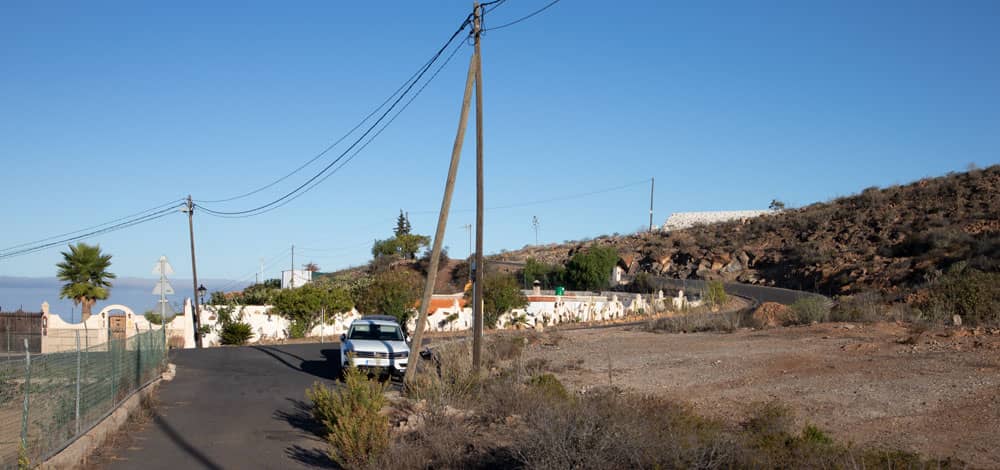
493,166 -> 1000,295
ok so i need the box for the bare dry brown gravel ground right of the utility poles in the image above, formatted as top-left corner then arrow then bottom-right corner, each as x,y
526,323 -> 1000,468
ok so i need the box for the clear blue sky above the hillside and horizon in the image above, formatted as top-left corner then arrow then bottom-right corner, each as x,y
0,0 -> 1000,300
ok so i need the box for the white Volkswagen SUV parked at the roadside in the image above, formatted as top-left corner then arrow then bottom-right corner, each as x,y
340,315 -> 410,375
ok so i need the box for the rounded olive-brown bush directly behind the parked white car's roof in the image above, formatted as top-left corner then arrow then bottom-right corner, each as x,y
351,269 -> 423,328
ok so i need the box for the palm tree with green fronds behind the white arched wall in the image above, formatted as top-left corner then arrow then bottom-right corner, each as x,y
56,243 -> 115,321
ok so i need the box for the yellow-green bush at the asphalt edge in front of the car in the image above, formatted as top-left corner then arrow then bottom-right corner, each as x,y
306,367 -> 389,468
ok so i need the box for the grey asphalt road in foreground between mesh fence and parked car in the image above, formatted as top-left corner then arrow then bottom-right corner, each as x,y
105,343 -> 340,469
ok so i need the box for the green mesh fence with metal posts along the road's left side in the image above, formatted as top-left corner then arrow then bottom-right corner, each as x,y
0,329 -> 166,468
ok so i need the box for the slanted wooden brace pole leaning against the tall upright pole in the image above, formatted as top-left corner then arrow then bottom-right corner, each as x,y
404,19 -> 478,383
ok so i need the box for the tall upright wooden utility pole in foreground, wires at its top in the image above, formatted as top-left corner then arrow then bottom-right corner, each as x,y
472,2 -> 486,371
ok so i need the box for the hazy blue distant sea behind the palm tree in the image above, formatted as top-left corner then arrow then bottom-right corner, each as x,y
0,276 -> 244,322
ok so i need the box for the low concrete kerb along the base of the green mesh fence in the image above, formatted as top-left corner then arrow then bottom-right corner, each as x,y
39,364 -> 176,470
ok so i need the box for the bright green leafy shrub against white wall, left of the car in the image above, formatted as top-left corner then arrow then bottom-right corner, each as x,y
274,283 -> 354,337
